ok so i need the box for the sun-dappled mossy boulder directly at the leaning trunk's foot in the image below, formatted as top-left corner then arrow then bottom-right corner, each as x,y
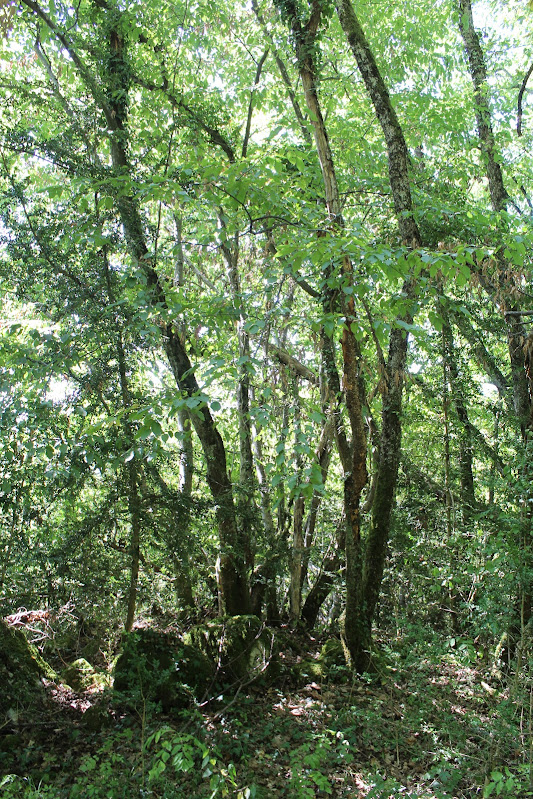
184,616 -> 278,682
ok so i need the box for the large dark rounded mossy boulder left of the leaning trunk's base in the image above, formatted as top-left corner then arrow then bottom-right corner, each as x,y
113,629 -> 214,712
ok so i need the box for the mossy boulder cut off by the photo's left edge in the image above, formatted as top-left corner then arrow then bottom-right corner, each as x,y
0,619 -> 58,725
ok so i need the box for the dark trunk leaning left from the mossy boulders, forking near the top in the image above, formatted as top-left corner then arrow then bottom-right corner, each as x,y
22,0 -> 250,615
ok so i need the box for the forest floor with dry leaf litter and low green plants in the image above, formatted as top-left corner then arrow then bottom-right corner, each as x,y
0,628 -> 533,799
